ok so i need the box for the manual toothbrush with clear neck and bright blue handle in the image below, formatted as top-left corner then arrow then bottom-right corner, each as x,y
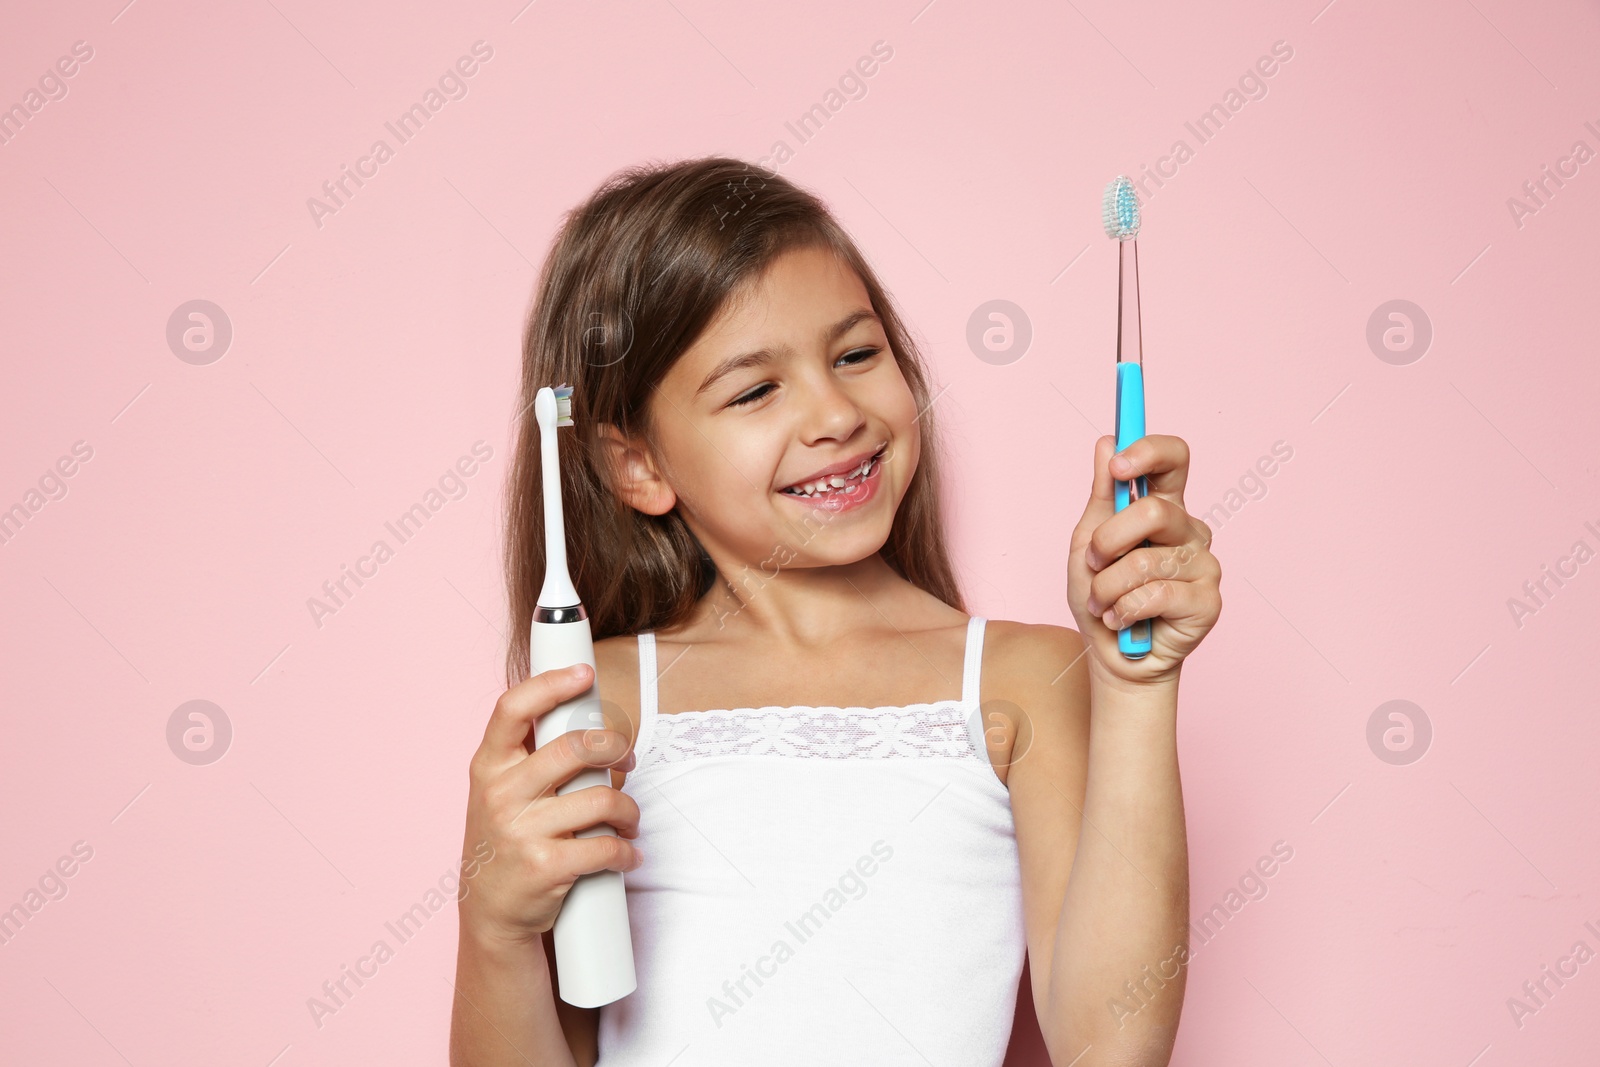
1101,174 -> 1150,659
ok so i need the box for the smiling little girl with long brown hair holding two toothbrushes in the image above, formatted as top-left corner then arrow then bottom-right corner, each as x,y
451,157 -> 1221,1067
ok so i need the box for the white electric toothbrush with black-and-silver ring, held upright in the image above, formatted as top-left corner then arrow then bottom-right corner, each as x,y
528,386 -> 638,1008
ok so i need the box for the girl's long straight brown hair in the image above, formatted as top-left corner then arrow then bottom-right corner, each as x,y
506,155 -> 966,685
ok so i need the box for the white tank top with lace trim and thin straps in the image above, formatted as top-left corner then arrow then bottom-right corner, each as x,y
598,617 -> 1027,1067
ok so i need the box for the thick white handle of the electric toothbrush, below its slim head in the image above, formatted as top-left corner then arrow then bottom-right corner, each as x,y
528,619 -> 638,1008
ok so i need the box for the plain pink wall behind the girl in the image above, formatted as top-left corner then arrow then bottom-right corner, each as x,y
0,0 -> 1600,1067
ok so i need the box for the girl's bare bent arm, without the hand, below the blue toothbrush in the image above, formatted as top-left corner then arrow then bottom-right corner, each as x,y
984,624 -> 1189,1067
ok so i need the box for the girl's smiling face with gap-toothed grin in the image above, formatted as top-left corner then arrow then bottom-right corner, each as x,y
635,248 -> 922,574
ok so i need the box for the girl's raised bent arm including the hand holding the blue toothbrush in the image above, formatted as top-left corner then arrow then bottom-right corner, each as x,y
1011,435 -> 1222,1067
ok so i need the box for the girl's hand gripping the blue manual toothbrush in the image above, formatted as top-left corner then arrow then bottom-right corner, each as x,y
1067,434 -> 1222,685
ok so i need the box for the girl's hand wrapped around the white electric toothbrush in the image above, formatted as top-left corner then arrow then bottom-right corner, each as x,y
459,664 -> 642,944
